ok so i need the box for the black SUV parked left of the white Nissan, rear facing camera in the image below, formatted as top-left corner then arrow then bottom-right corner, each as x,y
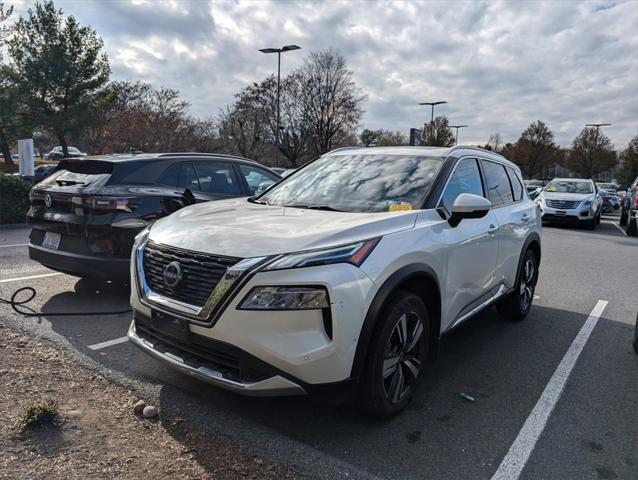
27,153 -> 280,281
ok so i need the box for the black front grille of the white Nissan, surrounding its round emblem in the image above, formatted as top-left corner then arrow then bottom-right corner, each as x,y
143,242 -> 241,307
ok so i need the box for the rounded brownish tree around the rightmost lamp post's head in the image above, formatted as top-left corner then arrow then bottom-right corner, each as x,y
566,127 -> 618,178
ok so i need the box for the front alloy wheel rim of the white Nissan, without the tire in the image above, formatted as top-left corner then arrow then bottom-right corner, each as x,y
383,312 -> 423,403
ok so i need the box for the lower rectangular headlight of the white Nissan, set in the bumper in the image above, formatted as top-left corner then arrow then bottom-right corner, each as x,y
238,286 -> 330,310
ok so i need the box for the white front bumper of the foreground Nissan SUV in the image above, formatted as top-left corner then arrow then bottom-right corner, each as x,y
129,246 -> 376,388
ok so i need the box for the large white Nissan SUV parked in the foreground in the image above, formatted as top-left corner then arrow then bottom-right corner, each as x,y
128,146 -> 541,417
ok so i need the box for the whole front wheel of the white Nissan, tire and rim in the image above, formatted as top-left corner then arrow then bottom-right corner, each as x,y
359,290 -> 430,419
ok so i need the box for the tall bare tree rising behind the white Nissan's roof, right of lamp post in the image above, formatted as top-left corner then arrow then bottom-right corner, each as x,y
298,49 -> 365,155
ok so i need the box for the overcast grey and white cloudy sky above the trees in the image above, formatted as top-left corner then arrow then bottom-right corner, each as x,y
12,0 -> 638,148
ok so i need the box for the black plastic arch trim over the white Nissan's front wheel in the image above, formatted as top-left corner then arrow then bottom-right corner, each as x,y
350,263 -> 441,382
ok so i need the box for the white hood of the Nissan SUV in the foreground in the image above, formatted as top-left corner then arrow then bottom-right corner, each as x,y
149,198 -> 417,258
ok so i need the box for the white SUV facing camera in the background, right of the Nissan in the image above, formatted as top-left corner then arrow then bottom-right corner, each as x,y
536,178 -> 603,230
